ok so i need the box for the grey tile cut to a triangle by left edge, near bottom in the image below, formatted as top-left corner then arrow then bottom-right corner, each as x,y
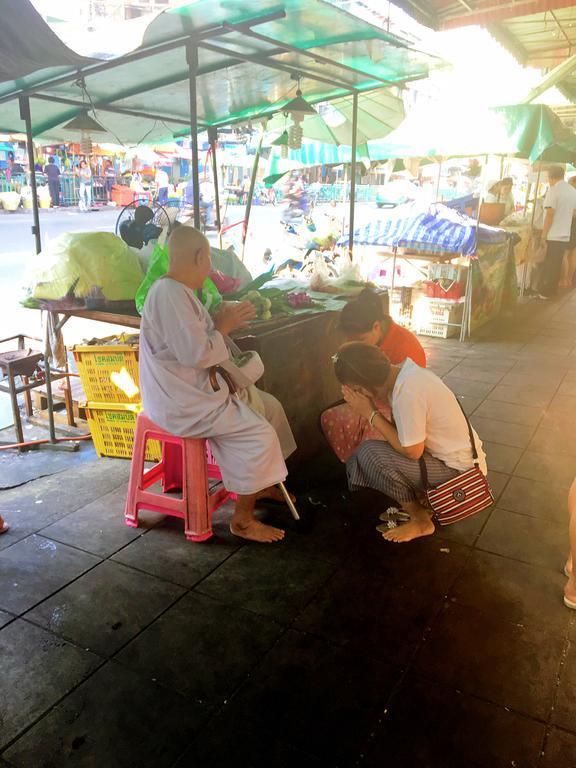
0,619 -> 102,752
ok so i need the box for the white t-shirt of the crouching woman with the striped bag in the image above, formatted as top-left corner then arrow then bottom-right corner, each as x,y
391,358 -> 488,475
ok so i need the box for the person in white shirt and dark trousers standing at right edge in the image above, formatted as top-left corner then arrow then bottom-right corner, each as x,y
540,165 -> 576,299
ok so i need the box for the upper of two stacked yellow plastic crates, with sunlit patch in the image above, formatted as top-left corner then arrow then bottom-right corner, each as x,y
72,344 -> 140,403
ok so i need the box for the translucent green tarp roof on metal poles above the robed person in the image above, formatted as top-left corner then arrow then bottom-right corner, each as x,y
0,0 -> 439,144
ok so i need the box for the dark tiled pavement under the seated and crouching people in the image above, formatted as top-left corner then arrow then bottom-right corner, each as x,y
0,298 -> 576,768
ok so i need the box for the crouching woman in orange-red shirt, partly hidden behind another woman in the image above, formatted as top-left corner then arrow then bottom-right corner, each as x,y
320,288 -> 426,463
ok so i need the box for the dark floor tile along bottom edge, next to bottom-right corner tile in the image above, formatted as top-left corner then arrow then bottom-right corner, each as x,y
363,675 -> 544,768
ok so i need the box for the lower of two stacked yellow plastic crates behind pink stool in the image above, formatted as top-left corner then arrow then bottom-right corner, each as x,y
84,403 -> 162,461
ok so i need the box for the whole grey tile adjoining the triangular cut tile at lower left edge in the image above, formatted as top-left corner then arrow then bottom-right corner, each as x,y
26,561 -> 185,656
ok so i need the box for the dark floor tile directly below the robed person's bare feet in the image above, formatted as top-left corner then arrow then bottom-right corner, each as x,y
196,545 -> 334,622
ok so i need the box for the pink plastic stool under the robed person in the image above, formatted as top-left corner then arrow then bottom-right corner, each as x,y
124,413 -> 235,541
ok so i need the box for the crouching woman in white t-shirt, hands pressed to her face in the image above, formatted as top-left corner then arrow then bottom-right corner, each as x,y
334,342 -> 488,542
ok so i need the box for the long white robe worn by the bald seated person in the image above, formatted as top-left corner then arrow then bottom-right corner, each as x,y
140,277 -> 296,495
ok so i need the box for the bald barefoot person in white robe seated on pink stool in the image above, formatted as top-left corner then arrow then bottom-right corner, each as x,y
140,226 -> 296,543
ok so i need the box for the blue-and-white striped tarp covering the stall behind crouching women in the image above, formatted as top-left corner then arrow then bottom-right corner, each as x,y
338,203 -> 507,256
